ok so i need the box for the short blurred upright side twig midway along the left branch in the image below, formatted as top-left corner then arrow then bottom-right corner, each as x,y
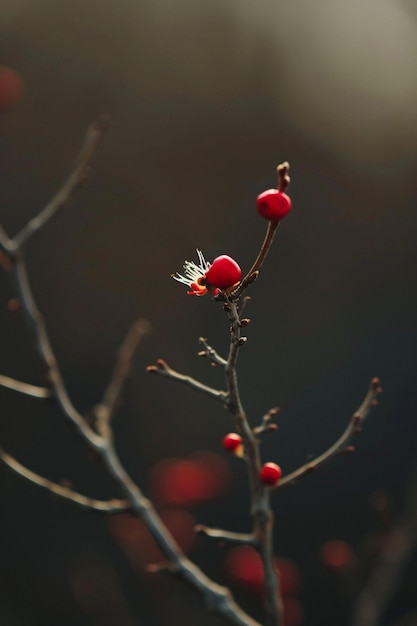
94,319 -> 150,432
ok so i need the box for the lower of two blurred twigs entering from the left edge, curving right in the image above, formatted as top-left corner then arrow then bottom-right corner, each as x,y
0,446 -> 130,513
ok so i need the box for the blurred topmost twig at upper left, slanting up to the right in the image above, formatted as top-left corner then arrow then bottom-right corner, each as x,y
5,116 -> 109,254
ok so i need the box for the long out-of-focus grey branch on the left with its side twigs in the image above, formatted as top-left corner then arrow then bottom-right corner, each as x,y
0,120 -> 260,626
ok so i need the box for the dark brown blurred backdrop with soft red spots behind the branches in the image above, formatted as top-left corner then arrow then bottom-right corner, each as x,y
0,0 -> 417,626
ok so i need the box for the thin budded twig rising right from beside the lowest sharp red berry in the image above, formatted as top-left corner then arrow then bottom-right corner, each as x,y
276,378 -> 382,489
